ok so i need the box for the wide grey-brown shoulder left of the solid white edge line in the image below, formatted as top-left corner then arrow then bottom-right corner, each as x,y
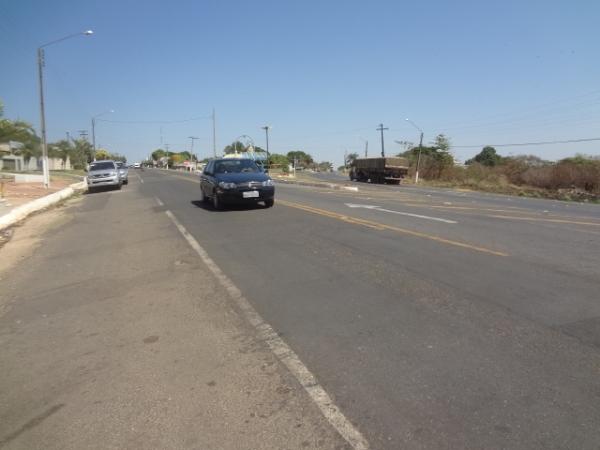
0,183 -> 349,450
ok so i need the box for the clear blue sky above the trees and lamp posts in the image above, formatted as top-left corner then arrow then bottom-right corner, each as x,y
0,0 -> 600,165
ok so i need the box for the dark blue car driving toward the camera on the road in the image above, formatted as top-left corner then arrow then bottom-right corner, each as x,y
200,158 -> 275,209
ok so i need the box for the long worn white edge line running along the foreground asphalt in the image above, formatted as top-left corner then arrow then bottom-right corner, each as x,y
164,209 -> 369,450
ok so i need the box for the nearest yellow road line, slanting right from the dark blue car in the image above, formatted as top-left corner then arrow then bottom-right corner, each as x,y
277,200 -> 508,256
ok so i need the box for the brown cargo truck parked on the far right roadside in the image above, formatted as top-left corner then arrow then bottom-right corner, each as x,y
350,157 -> 408,184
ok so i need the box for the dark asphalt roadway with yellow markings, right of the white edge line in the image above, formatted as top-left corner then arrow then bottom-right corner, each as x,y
137,170 -> 600,449
